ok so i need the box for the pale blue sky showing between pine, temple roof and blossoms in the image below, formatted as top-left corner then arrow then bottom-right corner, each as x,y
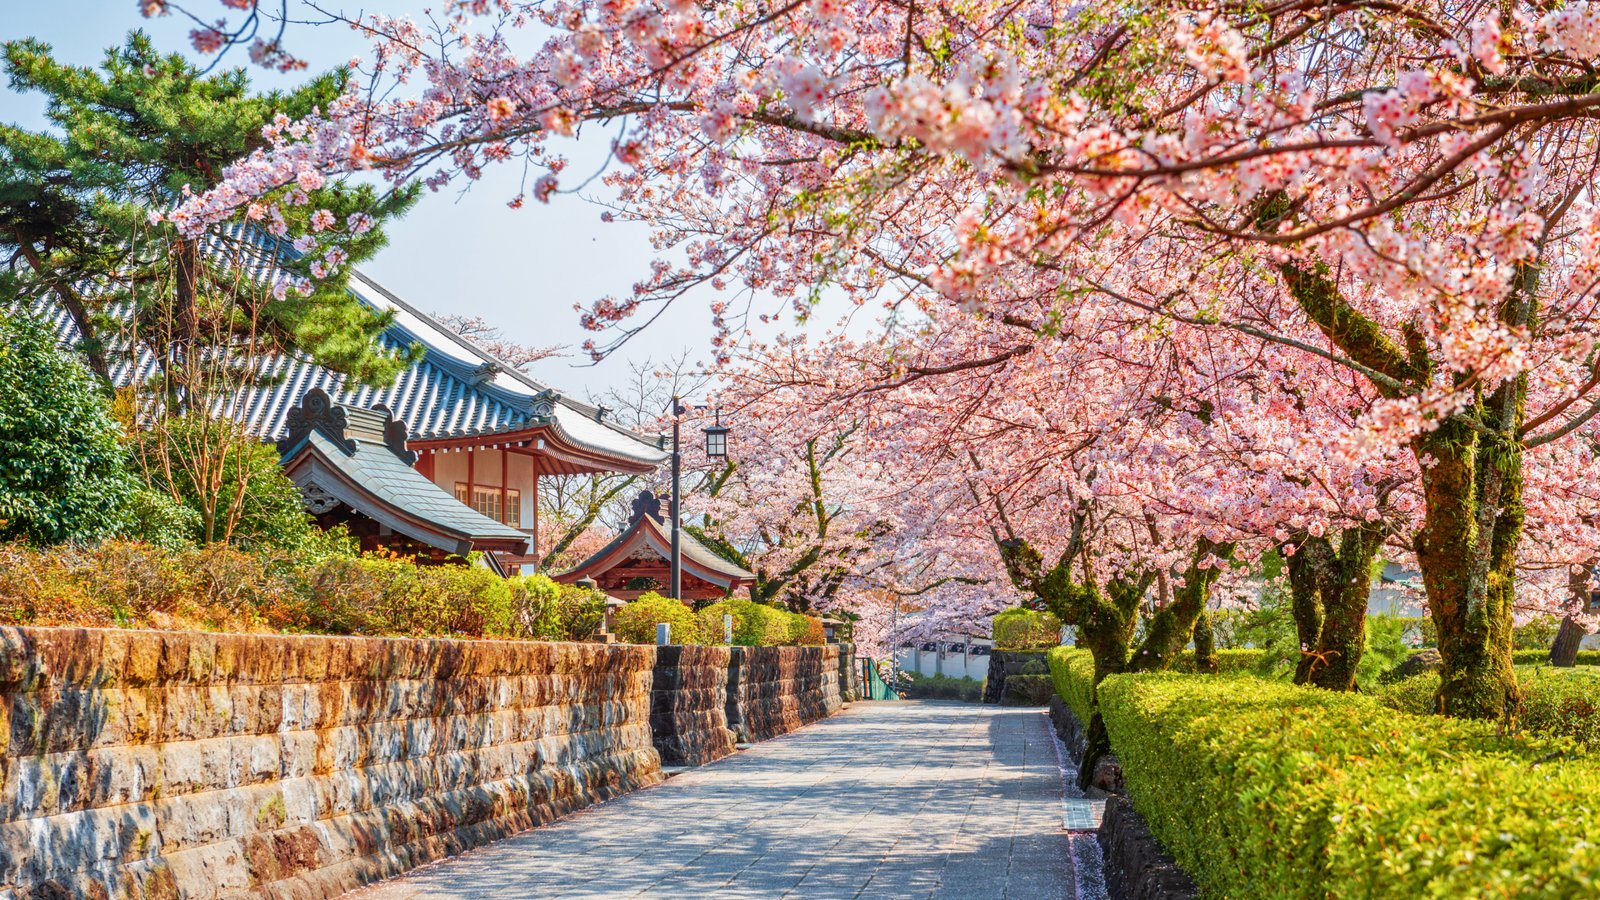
0,0 -> 761,396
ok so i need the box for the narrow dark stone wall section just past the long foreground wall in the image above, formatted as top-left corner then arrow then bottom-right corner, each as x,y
650,645 -> 734,765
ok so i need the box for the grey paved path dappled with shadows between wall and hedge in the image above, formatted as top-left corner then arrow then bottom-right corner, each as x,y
350,703 -> 1098,900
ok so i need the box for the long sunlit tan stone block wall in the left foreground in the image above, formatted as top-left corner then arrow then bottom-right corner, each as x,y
0,628 -> 661,900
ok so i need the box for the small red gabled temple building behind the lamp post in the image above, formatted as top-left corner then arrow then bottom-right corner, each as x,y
555,490 -> 755,601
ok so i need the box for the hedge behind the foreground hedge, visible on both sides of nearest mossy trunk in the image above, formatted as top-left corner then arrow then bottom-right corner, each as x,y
1374,666 -> 1600,746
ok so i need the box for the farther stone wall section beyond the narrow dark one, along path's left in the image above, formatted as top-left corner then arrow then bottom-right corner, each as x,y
728,644 -> 843,741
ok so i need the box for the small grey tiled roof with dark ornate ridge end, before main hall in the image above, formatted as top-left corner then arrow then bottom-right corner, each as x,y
278,388 -> 528,556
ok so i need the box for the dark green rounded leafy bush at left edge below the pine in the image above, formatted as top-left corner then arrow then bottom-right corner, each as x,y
0,314 -> 138,544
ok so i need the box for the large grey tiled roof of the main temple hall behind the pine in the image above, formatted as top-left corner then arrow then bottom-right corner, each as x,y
42,229 -> 667,472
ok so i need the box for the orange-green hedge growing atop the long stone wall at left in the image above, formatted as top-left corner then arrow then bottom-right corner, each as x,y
0,535 -> 605,641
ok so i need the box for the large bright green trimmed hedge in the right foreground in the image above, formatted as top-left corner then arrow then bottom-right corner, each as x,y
1099,674 -> 1600,898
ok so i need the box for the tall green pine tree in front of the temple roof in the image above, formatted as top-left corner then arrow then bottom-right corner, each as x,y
0,32 -> 418,392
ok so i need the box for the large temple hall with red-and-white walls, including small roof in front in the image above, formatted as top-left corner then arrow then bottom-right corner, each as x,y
45,238 -> 669,573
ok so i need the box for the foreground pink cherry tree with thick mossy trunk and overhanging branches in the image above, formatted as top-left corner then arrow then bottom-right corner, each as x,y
157,0 -> 1600,716
